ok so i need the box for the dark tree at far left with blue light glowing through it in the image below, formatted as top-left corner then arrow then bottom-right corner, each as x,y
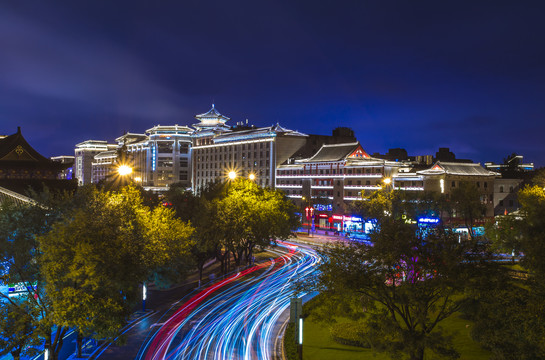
0,189 -> 71,359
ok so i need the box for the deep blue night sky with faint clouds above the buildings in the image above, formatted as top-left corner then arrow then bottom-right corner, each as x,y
0,0 -> 545,166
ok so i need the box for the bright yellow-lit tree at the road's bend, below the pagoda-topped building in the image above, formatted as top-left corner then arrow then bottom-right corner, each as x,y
166,178 -> 298,272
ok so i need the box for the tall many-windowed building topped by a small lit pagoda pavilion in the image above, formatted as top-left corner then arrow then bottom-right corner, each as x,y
193,106 -> 308,190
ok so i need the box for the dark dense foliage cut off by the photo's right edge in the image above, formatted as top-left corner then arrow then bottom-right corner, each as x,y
468,186 -> 545,360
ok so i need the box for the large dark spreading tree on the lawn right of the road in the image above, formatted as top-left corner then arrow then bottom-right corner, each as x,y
306,217 -> 494,360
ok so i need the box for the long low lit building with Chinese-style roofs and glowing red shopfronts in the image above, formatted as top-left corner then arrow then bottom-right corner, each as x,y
276,142 -> 498,230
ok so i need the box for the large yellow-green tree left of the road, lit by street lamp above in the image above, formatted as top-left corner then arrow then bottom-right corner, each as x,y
39,186 -> 192,356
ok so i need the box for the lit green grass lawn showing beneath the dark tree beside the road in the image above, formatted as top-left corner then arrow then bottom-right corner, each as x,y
303,315 -> 491,360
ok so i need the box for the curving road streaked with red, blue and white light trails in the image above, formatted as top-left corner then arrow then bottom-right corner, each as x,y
136,243 -> 320,360
